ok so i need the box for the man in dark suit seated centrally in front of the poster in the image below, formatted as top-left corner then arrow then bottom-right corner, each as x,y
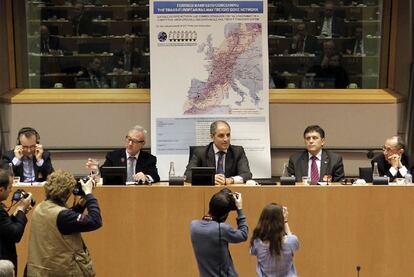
185,120 -> 252,185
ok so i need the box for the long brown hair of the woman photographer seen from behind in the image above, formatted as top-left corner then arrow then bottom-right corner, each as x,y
250,203 -> 285,255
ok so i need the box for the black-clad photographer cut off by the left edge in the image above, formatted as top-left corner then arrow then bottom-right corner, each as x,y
0,169 -> 32,271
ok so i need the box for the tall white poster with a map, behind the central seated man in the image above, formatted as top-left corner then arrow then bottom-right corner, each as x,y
150,1 -> 271,180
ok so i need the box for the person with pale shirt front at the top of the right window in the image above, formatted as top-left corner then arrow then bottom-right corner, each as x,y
316,1 -> 345,38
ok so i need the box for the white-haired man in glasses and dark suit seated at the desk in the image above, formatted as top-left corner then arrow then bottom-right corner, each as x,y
98,125 -> 160,184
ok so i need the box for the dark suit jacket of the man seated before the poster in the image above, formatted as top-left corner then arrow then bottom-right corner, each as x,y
185,142 -> 252,182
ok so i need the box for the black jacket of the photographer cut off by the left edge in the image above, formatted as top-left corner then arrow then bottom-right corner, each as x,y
0,203 -> 27,272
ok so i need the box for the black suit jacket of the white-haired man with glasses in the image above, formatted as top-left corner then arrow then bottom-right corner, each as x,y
102,148 -> 160,185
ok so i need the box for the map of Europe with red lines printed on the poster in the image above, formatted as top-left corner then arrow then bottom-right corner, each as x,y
184,23 -> 263,114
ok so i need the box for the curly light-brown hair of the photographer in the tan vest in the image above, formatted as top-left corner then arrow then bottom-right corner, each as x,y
44,170 -> 76,203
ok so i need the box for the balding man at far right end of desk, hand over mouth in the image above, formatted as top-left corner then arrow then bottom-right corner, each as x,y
371,136 -> 410,182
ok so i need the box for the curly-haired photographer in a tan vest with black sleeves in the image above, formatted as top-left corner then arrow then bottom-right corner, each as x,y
26,170 -> 102,277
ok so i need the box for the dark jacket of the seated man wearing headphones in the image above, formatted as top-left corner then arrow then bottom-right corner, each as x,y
2,150 -> 53,182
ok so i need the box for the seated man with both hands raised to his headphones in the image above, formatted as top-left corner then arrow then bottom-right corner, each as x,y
3,127 -> 53,183
